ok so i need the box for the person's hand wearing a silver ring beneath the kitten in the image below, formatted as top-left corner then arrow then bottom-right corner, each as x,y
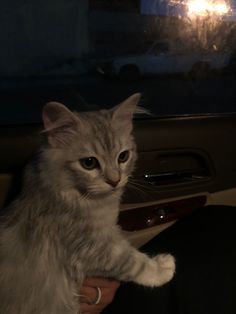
79,277 -> 120,314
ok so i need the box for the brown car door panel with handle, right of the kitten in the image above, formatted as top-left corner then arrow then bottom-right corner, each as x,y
122,115 -> 236,245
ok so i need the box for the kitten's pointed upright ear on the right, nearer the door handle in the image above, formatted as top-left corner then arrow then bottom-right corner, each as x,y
112,93 -> 141,132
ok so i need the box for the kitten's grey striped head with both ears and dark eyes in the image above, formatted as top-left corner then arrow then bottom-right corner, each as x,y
43,94 -> 140,198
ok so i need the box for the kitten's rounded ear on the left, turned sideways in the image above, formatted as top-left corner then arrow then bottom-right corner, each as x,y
42,102 -> 78,148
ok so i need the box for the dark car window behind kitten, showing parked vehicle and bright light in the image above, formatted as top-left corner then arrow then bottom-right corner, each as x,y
0,0 -> 236,124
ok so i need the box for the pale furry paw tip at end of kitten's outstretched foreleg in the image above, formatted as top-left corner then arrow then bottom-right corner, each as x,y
154,254 -> 175,285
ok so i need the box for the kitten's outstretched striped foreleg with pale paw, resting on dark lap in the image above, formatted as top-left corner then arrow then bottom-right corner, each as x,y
102,241 -> 175,287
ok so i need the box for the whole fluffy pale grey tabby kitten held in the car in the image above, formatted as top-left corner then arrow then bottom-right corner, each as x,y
0,94 -> 175,314
